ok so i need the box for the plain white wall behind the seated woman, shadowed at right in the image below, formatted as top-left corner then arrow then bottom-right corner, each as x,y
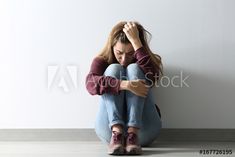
0,0 -> 235,128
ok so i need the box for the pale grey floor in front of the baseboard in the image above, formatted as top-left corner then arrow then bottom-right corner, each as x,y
0,141 -> 235,157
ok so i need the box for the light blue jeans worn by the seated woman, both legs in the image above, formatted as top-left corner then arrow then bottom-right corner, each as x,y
95,63 -> 162,146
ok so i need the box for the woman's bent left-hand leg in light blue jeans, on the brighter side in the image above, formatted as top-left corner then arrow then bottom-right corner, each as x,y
95,64 -> 125,143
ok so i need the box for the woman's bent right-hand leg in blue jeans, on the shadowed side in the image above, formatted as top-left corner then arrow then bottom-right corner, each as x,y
126,63 -> 162,146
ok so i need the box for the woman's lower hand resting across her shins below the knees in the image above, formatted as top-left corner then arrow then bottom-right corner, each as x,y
120,79 -> 149,97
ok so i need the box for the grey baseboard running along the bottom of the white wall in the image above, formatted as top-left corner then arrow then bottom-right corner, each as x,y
0,128 -> 235,142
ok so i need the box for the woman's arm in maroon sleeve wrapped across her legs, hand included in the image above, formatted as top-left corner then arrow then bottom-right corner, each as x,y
86,58 -> 148,97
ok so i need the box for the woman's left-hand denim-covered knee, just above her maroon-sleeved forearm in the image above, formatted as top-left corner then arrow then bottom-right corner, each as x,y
104,63 -> 124,78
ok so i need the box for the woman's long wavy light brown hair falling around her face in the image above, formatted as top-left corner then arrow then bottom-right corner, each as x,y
98,21 -> 163,76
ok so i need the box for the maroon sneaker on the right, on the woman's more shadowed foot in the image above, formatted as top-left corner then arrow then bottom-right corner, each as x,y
126,132 -> 142,155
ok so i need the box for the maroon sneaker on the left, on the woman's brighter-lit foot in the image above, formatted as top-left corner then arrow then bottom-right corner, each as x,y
108,131 -> 125,155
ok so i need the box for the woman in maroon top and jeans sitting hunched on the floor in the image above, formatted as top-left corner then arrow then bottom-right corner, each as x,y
86,22 -> 162,155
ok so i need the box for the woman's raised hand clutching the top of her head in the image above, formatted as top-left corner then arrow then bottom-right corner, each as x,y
123,22 -> 143,51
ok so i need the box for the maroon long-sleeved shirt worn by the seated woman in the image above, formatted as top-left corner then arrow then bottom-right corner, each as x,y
86,47 -> 159,95
